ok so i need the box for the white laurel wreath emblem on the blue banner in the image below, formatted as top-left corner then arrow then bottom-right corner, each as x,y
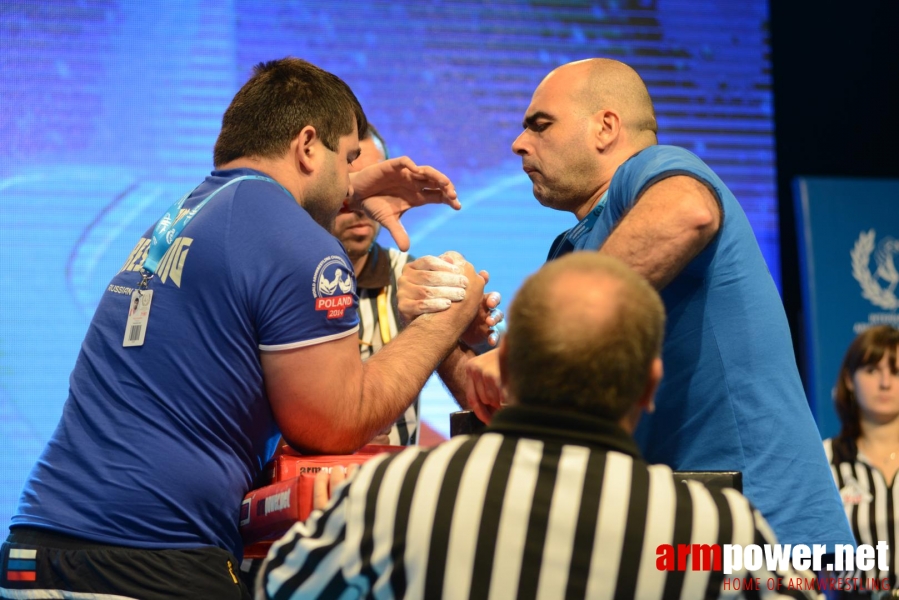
849,229 -> 899,310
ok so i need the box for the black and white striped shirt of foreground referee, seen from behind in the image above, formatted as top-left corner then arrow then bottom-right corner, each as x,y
257,407 -> 814,600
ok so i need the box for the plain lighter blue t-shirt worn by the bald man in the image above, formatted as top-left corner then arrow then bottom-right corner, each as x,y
551,146 -> 853,545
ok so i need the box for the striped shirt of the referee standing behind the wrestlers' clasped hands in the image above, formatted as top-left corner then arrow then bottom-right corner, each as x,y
356,244 -> 419,446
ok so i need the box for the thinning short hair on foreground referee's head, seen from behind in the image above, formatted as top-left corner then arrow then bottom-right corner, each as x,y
506,252 -> 665,421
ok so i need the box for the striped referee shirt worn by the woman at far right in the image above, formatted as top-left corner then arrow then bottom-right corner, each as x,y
824,438 -> 899,589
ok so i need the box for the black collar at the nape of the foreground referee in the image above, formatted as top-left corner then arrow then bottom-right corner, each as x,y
487,406 -> 640,458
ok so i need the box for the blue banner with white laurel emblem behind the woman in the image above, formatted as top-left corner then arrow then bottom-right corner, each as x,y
793,177 -> 899,437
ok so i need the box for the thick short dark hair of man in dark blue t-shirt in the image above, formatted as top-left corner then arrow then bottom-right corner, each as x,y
213,57 -> 368,166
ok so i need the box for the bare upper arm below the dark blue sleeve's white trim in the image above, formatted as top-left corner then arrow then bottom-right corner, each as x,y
261,333 -> 362,453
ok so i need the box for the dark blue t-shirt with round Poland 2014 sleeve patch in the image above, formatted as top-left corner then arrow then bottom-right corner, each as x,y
12,169 -> 358,557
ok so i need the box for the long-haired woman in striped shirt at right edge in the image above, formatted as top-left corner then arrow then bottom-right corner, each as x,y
824,325 -> 899,597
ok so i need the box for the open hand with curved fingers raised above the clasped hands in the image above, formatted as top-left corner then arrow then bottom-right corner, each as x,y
347,156 -> 462,251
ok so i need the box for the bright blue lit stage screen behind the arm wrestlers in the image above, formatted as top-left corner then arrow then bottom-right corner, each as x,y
0,0 -> 779,528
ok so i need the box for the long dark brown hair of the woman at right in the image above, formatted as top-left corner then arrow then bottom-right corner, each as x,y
833,325 -> 899,455
